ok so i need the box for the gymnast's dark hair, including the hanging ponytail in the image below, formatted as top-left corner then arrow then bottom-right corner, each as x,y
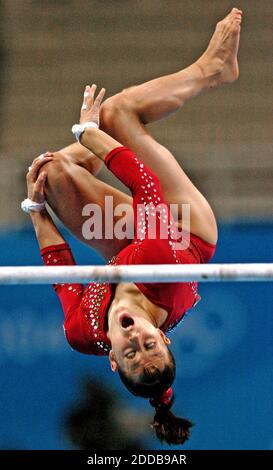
118,348 -> 193,444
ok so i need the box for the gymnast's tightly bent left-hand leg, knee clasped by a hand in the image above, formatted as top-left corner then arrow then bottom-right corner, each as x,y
43,143 -> 133,260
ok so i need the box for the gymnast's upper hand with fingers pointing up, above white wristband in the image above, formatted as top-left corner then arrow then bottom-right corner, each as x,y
80,85 -> 105,127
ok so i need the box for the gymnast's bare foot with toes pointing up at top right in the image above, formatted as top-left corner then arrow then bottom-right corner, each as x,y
196,8 -> 243,87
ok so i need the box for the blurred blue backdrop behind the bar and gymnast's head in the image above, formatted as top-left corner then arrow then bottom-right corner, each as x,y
0,223 -> 273,449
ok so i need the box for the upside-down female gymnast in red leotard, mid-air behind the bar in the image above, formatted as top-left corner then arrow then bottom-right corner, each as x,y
23,8 -> 242,444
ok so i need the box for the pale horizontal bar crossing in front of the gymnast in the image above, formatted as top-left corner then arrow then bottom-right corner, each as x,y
0,263 -> 273,285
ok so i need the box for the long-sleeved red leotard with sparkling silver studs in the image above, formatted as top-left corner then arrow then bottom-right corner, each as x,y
41,147 -> 215,355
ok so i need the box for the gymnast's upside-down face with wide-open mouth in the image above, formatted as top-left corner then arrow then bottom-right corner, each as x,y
109,313 -> 170,380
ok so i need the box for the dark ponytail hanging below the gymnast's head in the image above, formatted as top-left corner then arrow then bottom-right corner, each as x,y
150,388 -> 193,444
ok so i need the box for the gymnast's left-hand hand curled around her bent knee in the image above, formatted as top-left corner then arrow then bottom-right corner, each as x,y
26,152 -> 53,204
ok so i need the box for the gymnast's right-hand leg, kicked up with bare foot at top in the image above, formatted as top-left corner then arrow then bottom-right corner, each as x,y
102,9 -> 242,243
